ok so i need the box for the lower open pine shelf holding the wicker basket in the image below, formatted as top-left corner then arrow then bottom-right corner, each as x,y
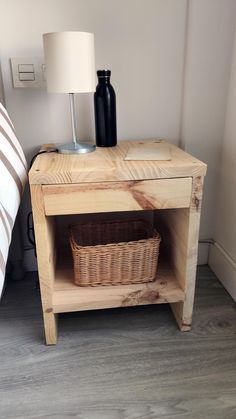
52,253 -> 185,313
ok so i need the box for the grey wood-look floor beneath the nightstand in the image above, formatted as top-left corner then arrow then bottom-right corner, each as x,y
0,267 -> 236,419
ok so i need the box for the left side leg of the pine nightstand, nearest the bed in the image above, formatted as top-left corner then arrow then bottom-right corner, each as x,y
30,185 -> 57,345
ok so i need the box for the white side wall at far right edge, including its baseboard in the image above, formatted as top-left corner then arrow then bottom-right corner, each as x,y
210,26 -> 236,300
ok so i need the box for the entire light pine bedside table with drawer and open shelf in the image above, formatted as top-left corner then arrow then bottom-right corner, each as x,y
29,140 -> 206,344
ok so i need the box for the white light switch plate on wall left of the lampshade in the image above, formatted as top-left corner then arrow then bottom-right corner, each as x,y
11,57 -> 46,88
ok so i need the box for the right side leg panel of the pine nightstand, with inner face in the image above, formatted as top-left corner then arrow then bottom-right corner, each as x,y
155,177 -> 203,331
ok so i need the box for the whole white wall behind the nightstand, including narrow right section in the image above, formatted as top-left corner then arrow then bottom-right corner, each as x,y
0,0 -> 236,270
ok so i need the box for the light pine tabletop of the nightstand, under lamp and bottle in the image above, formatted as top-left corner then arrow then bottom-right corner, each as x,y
29,140 -> 207,185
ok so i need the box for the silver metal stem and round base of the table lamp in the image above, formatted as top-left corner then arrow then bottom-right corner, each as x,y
57,93 -> 96,154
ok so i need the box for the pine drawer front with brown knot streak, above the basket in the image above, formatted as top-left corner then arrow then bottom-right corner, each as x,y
42,178 -> 192,215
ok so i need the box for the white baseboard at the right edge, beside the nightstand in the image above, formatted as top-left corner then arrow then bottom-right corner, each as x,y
208,243 -> 236,301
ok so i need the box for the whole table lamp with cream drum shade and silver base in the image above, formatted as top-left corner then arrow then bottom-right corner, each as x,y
43,32 -> 95,154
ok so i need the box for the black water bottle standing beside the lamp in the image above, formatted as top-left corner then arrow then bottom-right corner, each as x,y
94,70 -> 117,147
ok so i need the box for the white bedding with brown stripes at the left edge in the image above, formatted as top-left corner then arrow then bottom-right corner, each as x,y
0,103 -> 27,297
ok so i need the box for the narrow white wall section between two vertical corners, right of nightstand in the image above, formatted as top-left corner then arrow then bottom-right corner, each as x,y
181,0 -> 236,253
